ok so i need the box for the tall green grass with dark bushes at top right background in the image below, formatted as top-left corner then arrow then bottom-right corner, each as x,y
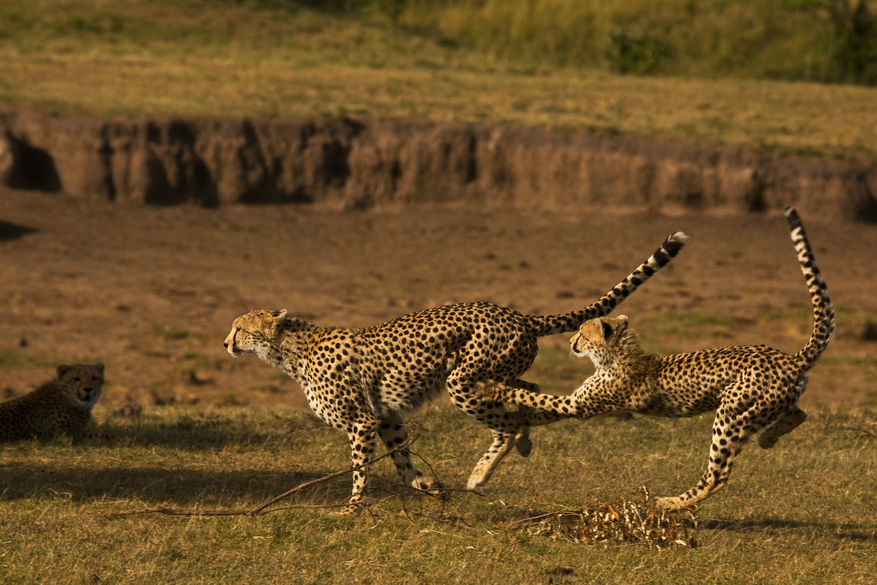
396,0 -> 877,80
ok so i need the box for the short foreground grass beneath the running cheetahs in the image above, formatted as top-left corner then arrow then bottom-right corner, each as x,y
0,404 -> 877,584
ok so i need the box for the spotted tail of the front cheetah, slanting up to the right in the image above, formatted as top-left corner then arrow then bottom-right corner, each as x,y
529,232 -> 688,336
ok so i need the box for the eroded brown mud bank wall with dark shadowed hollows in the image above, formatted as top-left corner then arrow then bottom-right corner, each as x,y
0,112 -> 877,222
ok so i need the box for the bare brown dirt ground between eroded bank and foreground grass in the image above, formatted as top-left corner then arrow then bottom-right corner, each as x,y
0,189 -> 877,410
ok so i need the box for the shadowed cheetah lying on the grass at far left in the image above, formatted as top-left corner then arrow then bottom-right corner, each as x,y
0,363 -> 104,442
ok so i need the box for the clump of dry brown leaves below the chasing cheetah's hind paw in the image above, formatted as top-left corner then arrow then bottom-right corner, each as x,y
518,486 -> 697,549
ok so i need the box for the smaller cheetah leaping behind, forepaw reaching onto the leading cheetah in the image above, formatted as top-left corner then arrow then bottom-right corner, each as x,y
476,208 -> 834,510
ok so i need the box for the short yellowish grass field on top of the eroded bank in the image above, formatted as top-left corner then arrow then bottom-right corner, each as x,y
0,0 -> 877,164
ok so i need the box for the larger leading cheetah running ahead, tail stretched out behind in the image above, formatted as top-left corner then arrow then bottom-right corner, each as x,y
224,232 -> 688,513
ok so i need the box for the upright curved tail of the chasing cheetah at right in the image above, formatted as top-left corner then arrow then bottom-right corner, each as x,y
785,207 -> 834,369
